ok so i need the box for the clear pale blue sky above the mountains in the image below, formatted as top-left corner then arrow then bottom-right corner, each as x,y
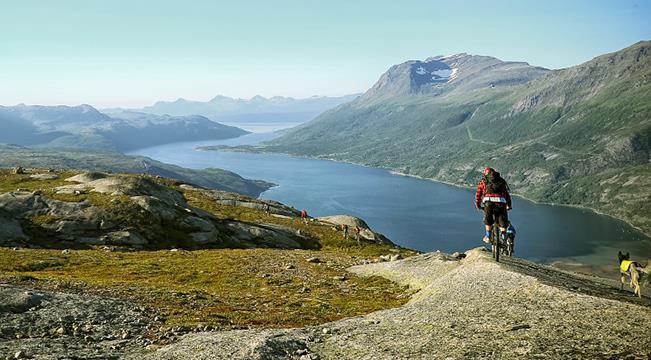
0,0 -> 651,107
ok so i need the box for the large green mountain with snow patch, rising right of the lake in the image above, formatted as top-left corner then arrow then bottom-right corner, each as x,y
264,41 -> 651,234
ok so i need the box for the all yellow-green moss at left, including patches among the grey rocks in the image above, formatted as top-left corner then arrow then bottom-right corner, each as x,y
0,170 -> 414,328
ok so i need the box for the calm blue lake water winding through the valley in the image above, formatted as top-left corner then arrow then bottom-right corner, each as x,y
130,133 -> 651,266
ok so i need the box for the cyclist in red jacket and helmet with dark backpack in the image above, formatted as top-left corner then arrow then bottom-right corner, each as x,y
475,167 -> 512,244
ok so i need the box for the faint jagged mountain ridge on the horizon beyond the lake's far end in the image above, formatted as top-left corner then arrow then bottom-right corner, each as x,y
102,94 -> 359,124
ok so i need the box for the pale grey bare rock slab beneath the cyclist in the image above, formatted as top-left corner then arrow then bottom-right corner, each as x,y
141,249 -> 651,360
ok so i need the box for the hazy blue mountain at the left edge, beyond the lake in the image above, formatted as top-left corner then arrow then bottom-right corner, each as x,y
0,105 -> 247,151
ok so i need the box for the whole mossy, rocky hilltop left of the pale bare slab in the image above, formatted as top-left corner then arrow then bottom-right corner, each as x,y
0,168 -> 414,359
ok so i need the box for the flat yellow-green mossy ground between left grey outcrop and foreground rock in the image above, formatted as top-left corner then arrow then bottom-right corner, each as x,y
0,249 -> 406,328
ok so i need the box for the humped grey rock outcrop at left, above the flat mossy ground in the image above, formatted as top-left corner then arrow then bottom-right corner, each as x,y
0,173 -> 313,249
